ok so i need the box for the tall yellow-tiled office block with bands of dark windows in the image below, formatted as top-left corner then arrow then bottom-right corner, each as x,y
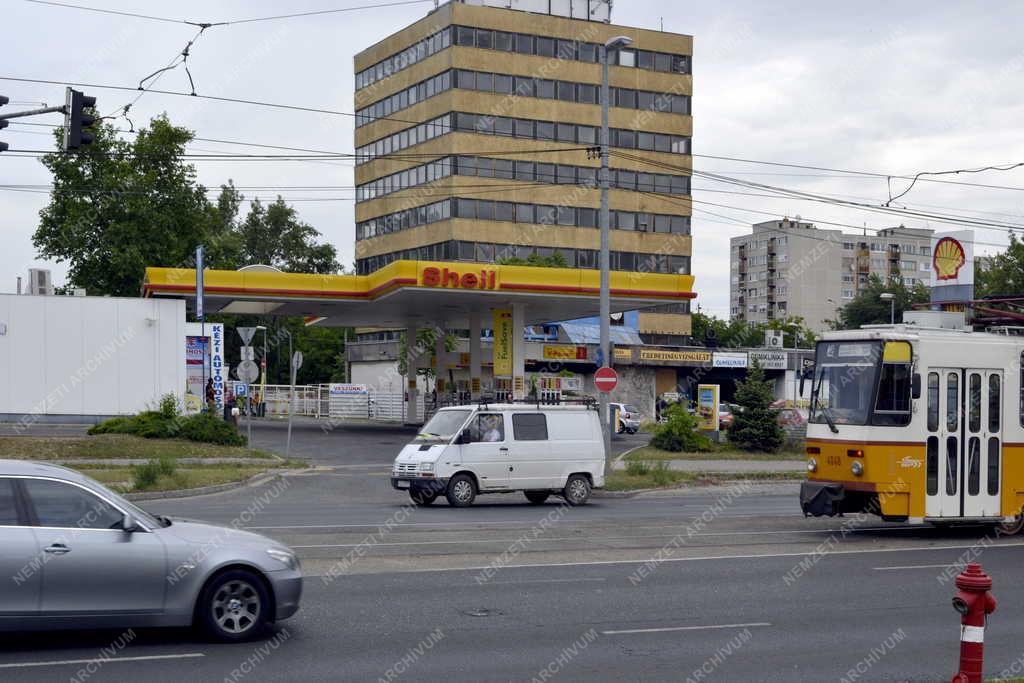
354,2 -> 693,343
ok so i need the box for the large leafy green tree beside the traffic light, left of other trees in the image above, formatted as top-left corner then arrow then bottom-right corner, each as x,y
33,117 -> 211,296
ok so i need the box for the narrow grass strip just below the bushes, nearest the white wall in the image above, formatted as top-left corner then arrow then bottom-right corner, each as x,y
0,434 -> 274,461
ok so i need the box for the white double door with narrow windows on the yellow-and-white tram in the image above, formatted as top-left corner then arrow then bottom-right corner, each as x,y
925,368 -> 1002,517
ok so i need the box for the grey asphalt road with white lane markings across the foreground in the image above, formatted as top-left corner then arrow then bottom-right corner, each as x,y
0,419 -> 1024,683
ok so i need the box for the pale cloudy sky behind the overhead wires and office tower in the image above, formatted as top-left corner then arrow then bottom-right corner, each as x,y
0,0 -> 1024,315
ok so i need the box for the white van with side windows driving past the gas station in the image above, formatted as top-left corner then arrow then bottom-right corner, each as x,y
391,403 -> 604,507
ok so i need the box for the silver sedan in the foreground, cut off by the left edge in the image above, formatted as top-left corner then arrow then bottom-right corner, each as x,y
0,460 -> 302,642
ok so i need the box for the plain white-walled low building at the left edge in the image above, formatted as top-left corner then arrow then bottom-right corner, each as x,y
0,294 -> 185,423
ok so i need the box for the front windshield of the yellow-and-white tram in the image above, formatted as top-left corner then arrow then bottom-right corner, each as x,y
810,341 -> 882,425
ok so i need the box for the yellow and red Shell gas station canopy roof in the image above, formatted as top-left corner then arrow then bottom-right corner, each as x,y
142,261 -> 696,329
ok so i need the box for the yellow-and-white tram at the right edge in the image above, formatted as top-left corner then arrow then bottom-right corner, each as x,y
800,325 -> 1024,531
